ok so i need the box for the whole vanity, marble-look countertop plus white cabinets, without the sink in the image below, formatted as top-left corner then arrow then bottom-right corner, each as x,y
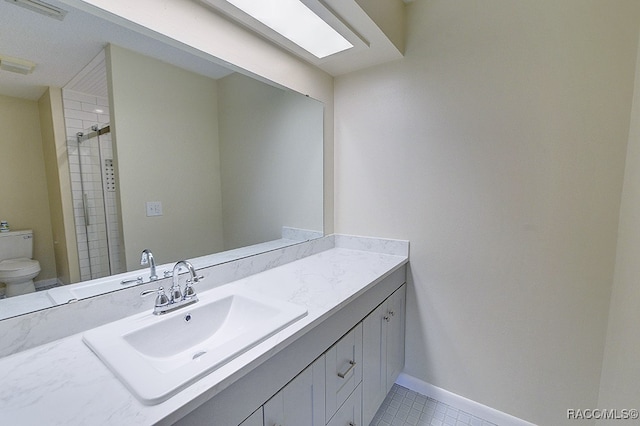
0,235 -> 408,426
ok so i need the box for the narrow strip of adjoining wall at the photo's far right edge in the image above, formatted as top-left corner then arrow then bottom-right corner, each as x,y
598,23 -> 640,424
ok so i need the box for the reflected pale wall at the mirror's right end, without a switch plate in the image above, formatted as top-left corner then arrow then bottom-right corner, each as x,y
218,73 -> 323,250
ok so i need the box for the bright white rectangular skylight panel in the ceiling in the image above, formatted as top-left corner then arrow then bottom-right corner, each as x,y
227,0 -> 353,58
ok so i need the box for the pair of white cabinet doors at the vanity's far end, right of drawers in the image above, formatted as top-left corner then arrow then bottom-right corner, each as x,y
362,285 -> 406,425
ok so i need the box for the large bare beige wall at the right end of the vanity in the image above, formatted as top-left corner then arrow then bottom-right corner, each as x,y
335,0 -> 640,425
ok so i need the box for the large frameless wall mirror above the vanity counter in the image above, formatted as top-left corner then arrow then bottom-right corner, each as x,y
0,1 -> 323,319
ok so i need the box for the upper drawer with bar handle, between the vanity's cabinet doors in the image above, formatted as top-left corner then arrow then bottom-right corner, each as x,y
325,323 -> 362,420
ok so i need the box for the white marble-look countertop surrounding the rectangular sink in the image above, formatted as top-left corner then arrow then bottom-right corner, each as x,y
0,237 -> 408,425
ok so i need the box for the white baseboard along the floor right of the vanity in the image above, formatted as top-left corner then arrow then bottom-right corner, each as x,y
396,373 -> 536,426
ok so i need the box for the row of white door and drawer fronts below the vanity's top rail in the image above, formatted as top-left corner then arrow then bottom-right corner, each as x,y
254,285 -> 406,426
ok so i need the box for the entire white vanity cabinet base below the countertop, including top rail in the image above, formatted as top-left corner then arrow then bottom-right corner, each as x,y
175,269 -> 406,426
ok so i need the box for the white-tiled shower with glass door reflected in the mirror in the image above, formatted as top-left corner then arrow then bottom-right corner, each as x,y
63,89 -> 124,280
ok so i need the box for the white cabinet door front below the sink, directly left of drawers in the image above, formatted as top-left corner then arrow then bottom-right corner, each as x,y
261,357 -> 325,426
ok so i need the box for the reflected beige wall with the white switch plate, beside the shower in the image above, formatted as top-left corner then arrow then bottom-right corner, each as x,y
107,46 -> 228,270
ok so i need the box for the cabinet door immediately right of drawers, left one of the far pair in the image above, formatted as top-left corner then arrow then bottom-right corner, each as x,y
362,302 -> 387,425
